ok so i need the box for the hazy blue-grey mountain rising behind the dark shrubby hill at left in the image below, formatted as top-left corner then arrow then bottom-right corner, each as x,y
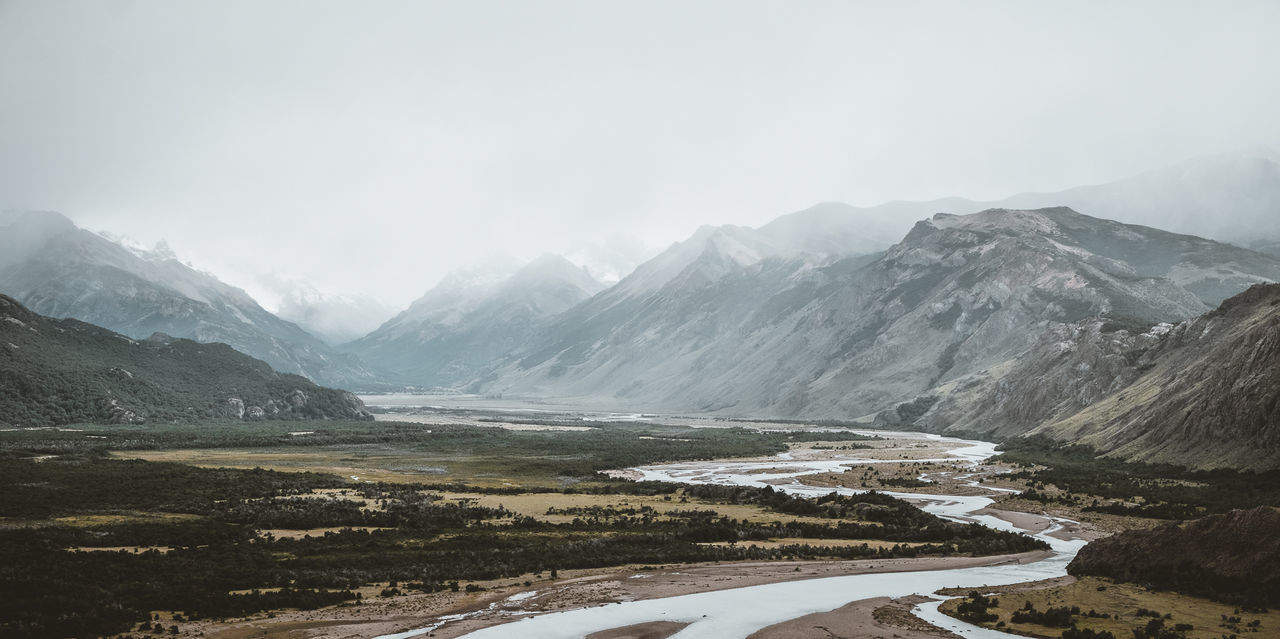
0,211 -> 375,385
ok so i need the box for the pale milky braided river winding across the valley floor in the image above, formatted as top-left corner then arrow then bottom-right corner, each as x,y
391,433 -> 1085,639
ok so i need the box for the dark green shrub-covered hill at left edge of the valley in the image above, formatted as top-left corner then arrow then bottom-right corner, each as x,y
0,295 -> 372,426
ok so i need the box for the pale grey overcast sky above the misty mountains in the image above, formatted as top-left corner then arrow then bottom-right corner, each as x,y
0,0 -> 1280,309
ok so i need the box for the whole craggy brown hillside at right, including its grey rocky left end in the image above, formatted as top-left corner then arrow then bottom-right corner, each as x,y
914,284 -> 1280,469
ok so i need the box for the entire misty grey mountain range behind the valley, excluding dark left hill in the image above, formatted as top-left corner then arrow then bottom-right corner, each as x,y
0,150 -> 1280,467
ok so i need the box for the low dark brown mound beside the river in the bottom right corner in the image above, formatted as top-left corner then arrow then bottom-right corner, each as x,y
1066,506 -> 1280,606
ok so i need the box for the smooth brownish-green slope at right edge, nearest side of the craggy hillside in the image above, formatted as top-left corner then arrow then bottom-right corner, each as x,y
1034,284 -> 1280,469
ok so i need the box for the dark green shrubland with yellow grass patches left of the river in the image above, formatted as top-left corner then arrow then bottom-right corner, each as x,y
0,423 -> 1043,638
